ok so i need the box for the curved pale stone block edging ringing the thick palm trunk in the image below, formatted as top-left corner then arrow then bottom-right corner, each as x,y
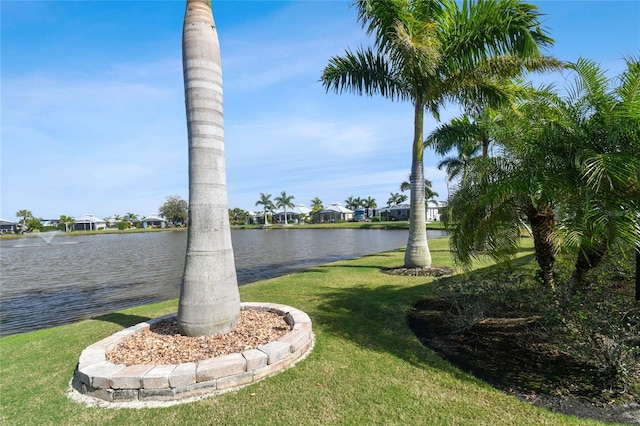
72,302 -> 314,403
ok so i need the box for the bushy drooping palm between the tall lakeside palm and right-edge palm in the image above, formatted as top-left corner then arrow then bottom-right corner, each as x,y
443,81 -> 563,288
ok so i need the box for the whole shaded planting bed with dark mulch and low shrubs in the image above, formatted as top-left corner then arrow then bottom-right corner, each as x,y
408,248 -> 640,423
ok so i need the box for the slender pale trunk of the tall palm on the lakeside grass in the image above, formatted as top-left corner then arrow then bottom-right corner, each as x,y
404,99 -> 431,268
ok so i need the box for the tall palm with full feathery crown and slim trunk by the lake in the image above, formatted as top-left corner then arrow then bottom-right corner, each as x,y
321,0 -> 557,267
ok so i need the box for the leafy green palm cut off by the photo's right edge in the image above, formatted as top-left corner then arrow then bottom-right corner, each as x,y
557,57 -> 640,294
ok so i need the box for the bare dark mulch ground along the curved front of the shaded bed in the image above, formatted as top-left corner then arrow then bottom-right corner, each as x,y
408,299 -> 640,424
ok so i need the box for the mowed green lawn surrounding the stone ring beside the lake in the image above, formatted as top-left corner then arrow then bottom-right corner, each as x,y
0,238 -> 597,425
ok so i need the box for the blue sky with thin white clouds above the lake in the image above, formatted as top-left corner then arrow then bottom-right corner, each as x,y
0,0 -> 640,220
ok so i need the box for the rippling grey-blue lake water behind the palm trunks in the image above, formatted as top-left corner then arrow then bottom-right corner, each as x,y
0,228 -> 442,336
